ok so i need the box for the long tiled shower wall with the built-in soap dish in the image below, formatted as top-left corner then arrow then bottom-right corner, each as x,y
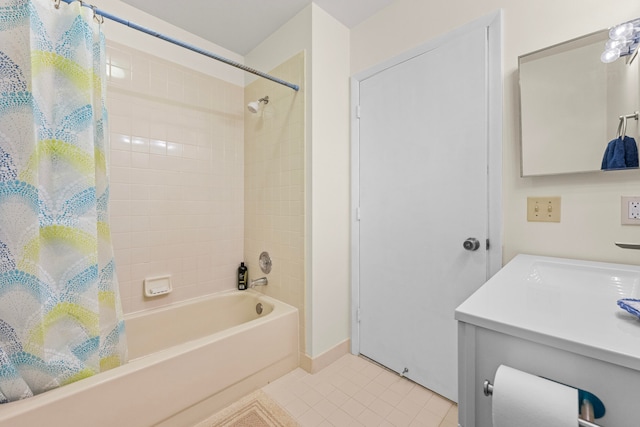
107,42 -> 244,313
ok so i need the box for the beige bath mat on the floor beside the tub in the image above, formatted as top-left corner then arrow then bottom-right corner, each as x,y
196,390 -> 300,427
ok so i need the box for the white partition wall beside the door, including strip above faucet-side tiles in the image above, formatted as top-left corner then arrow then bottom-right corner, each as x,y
245,4 -> 349,357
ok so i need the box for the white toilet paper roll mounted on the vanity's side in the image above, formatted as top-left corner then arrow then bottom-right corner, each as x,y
492,365 -> 578,427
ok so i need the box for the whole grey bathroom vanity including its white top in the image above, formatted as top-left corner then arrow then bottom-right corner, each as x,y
455,255 -> 640,427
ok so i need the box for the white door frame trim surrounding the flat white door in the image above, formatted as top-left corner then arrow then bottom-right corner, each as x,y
350,10 -> 503,354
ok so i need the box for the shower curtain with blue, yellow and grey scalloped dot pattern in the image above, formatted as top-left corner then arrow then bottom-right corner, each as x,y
0,0 -> 126,403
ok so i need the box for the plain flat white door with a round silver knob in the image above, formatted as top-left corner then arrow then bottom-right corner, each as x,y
356,24 -> 496,401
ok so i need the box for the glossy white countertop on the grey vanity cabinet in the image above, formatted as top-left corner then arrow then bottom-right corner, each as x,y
455,254 -> 640,370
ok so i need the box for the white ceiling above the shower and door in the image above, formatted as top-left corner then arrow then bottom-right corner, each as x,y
117,0 -> 394,55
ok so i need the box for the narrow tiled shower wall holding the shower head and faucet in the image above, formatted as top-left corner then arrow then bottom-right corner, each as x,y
244,52 -> 305,350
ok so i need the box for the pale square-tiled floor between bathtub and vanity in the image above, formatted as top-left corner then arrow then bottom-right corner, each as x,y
262,354 -> 458,427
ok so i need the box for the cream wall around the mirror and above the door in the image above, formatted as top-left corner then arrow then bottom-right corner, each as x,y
352,0 -> 640,264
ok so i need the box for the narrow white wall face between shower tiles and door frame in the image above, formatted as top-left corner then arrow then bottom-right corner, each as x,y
307,6 -> 350,357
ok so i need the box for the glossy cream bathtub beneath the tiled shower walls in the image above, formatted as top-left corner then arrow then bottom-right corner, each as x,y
0,290 -> 298,427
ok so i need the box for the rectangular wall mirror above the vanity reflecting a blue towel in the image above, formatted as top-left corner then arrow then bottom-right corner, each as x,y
518,30 -> 640,177
